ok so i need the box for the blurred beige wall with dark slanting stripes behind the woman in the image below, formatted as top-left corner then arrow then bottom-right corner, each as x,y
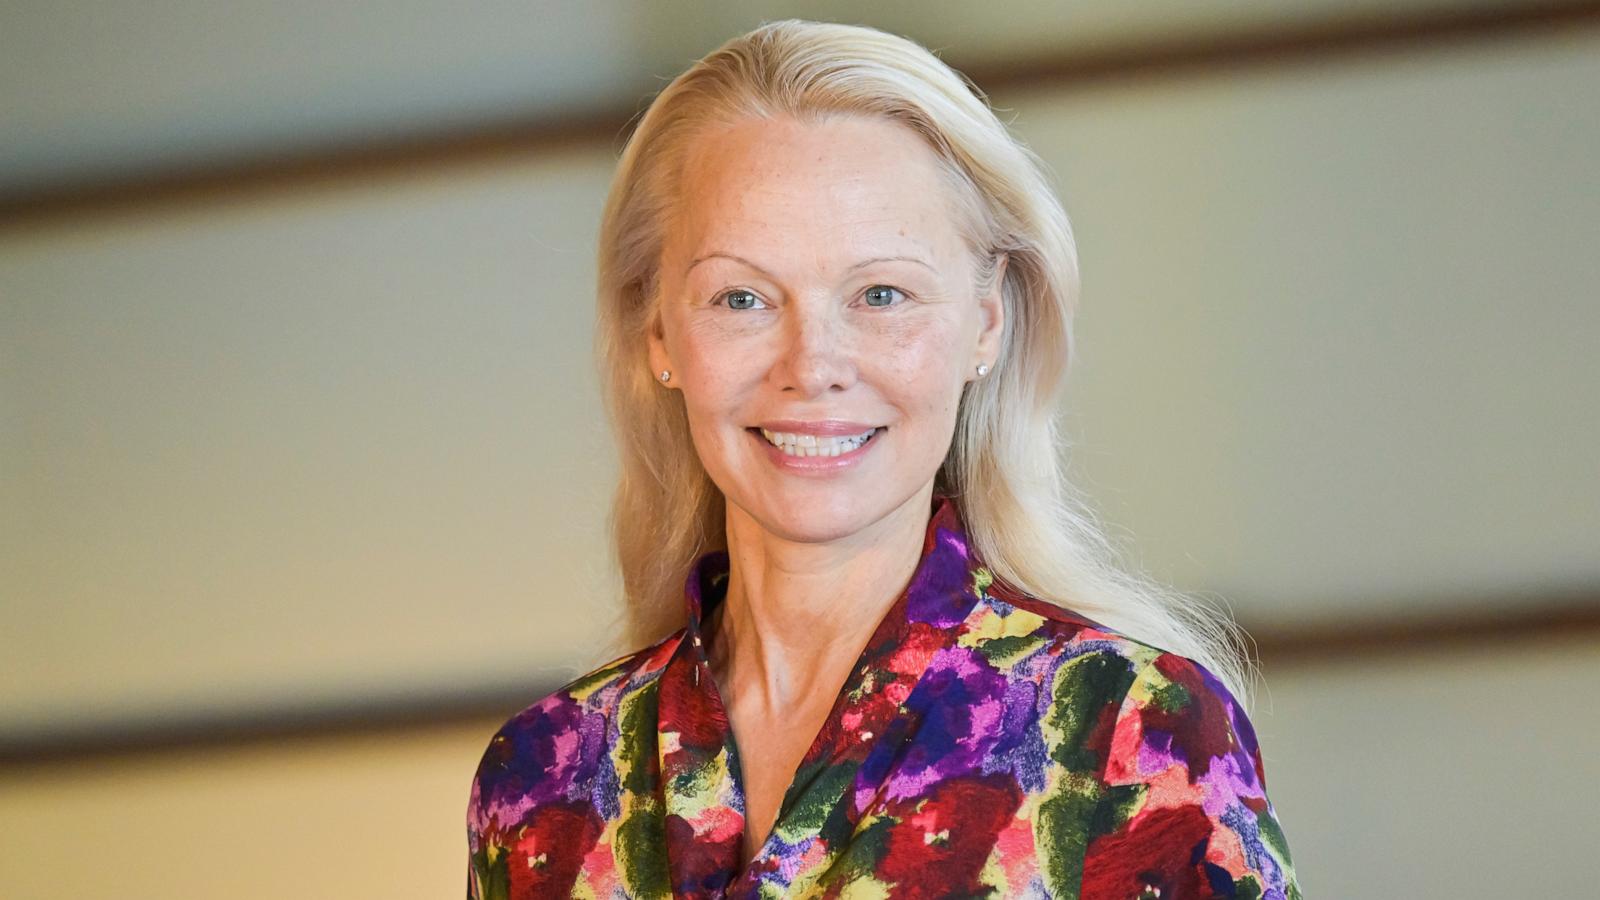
0,0 -> 1600,898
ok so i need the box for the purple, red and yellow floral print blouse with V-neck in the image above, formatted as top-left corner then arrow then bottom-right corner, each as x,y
467,498 -> 1301,900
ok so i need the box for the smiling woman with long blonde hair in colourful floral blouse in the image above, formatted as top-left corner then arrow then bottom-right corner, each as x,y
467,21 -> 1299,900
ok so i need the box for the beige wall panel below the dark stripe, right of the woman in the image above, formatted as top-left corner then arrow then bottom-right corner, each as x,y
1253,634 -> 1600,900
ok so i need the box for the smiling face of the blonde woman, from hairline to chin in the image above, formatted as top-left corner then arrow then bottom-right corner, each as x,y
650,117 -> 1003,543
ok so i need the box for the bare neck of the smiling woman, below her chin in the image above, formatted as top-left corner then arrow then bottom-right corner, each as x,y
706,484 -> 933,711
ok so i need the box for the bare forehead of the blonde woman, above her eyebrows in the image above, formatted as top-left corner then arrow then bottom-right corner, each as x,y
667,115 -> 963,266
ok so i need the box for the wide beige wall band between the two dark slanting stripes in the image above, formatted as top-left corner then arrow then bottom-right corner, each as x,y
0,32 -> 1600,735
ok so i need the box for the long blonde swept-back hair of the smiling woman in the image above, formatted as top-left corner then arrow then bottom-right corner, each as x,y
597,19 -> 1250,700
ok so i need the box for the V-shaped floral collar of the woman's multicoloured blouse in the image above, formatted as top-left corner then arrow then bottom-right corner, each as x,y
658,496 -> 990,897
